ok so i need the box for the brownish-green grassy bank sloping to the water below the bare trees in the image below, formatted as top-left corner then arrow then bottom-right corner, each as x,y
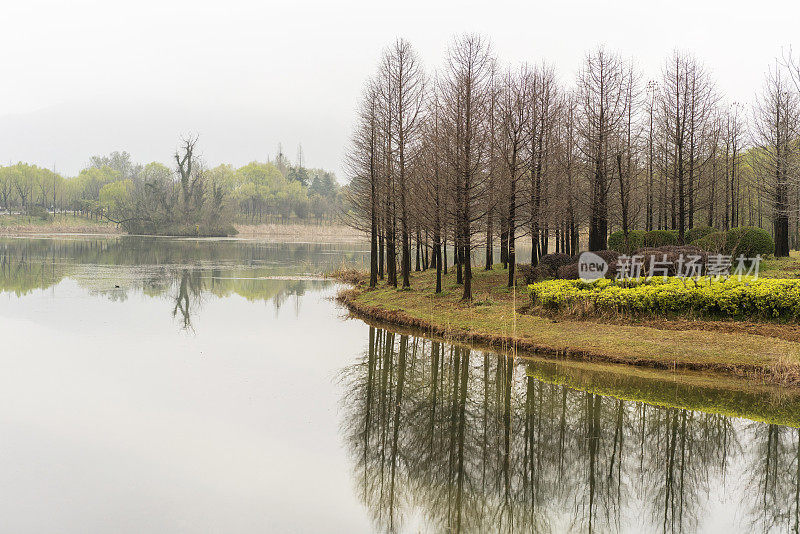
339,269 -> 800,385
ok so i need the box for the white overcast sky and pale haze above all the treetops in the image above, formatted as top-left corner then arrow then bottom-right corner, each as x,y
0,0 -> 800,180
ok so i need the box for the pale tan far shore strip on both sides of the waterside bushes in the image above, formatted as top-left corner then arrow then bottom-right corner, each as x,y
0,214 -> 366,243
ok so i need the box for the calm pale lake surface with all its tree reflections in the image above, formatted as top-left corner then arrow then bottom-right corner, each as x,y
0,237 -> 800,533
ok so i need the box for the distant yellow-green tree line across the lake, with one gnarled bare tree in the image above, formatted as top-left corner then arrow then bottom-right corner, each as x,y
0,138 -> 341,233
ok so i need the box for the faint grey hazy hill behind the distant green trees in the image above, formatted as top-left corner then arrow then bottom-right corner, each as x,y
0,99 -> 339,176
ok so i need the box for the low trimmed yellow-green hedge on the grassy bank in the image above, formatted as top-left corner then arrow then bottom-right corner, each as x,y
528,277 -> 800,319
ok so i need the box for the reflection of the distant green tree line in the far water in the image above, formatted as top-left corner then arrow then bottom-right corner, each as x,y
0,236 -> 363,328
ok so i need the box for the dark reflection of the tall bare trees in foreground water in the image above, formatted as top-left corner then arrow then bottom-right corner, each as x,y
341,327 -> 800,532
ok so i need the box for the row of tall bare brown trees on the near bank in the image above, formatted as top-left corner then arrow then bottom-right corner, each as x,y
348,34 -> 800,300
